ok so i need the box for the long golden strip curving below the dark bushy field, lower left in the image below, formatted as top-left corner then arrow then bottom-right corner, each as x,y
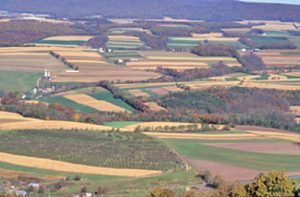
0,153 -> 161,177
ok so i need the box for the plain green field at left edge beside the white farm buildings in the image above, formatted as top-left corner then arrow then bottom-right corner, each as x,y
0,71 -> 42,92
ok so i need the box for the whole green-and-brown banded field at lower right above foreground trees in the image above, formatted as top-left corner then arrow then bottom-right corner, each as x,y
159,133 -> 300,181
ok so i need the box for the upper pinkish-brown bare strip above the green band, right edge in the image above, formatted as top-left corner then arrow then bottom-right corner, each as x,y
205,142 -> 300,155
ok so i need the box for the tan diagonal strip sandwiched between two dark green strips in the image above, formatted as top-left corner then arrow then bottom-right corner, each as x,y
64,94 -> 129,112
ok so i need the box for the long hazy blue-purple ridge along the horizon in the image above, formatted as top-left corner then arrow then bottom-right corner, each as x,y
0,0 -> 300,21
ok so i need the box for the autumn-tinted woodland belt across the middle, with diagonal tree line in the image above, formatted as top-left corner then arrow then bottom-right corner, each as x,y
0,86 -> 300,131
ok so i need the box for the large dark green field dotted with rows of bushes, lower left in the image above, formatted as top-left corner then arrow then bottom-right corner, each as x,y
0,130 -> 178,173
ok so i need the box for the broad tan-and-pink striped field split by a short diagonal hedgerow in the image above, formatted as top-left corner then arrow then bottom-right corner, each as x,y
0,45 -> 159,82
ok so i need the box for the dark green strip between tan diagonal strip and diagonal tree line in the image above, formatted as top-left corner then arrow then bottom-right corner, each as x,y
89,92 -> 135,112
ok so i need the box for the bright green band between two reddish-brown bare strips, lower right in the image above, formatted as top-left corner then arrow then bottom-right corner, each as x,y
163,139 -> 300,171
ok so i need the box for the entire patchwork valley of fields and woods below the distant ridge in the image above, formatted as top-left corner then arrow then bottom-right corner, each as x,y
0,16 -> 300,197
